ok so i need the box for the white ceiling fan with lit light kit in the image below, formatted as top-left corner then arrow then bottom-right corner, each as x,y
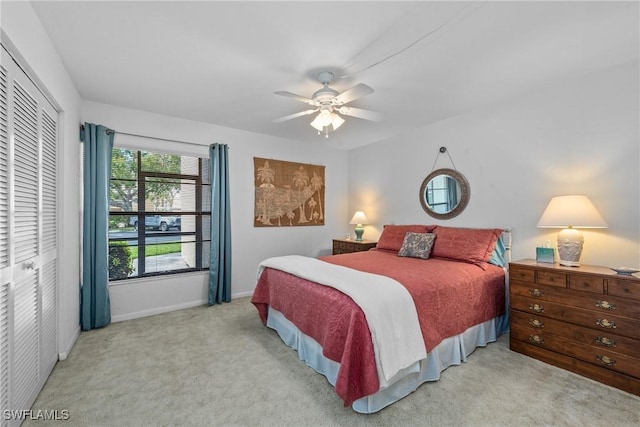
274,71 -> 382,138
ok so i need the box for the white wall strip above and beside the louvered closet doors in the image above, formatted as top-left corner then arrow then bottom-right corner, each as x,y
0,2 -> 80,359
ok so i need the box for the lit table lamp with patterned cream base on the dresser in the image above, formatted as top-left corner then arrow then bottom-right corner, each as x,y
538,195 -> 607,267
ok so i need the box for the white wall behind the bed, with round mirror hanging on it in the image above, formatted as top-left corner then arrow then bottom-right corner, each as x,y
349,61 -> 640,266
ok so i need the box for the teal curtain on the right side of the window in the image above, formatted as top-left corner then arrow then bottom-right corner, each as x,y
209,144 -> 231,305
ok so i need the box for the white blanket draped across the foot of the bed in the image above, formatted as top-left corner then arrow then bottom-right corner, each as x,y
258,255 -> 427,388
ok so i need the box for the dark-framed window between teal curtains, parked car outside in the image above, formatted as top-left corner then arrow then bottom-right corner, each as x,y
109,148 -> 211,280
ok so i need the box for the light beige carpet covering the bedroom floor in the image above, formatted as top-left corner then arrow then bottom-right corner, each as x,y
23,298 -> 640,427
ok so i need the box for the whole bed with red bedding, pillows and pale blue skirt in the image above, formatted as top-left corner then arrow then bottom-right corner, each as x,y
251,225 -> 508,413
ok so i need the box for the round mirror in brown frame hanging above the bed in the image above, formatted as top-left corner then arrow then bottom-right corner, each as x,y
420,169 -> 469,219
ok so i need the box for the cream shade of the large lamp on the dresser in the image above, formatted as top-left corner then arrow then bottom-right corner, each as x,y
538,195 -> 608,228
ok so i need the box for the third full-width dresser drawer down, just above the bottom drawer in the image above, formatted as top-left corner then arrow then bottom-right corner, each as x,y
510,310 -> 640,357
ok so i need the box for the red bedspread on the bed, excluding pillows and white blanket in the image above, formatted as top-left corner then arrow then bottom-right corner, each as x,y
251,250 -> 505,406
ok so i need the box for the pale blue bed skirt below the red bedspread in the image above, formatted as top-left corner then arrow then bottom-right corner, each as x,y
267,307 -> 509,414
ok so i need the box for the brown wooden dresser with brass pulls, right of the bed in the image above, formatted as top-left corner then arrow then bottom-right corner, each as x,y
509,260 -> 640,396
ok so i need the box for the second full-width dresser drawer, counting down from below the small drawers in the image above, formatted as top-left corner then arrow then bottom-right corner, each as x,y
511,294 -> 640,339
